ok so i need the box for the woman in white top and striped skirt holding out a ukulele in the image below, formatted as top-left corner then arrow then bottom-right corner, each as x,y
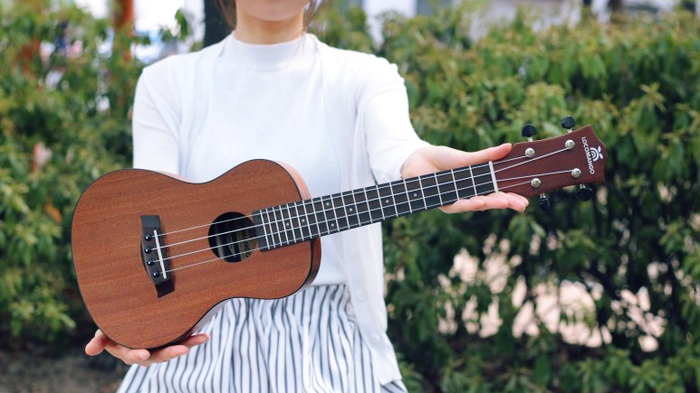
85,0 -> 528,392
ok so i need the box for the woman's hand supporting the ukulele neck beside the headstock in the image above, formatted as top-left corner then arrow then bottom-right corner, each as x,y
401,143 -> 529,213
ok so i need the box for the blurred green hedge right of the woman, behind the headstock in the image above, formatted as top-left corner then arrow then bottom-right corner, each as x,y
319,3 -> 700,392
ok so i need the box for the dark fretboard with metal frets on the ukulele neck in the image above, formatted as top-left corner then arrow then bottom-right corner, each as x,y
253,163 -> 498,251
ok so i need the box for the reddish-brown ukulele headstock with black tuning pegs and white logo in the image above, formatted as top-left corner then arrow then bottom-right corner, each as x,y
493,121 -> 607,204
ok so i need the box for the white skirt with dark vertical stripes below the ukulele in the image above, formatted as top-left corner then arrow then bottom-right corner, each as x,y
117,285 -> 406,393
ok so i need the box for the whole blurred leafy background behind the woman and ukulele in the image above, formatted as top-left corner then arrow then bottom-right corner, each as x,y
0,0 -> 700,393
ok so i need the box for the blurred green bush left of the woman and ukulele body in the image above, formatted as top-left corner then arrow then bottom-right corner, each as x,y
0,1 -> 140,343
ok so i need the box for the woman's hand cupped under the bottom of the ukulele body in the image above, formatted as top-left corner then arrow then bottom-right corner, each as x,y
85,330 -> 209,366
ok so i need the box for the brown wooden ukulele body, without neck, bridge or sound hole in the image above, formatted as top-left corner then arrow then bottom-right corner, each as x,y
72,160 -> 321,348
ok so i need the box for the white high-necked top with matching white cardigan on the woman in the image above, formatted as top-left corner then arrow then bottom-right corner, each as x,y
133,34 -> 426,383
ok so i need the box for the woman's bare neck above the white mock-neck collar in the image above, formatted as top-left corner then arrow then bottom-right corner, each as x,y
234,12 -> 305,44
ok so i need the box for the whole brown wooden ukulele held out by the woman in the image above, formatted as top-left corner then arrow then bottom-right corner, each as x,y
72,126 -> 606,349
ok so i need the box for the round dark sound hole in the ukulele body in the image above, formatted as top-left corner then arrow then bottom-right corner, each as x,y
209,212 -> 258,262
